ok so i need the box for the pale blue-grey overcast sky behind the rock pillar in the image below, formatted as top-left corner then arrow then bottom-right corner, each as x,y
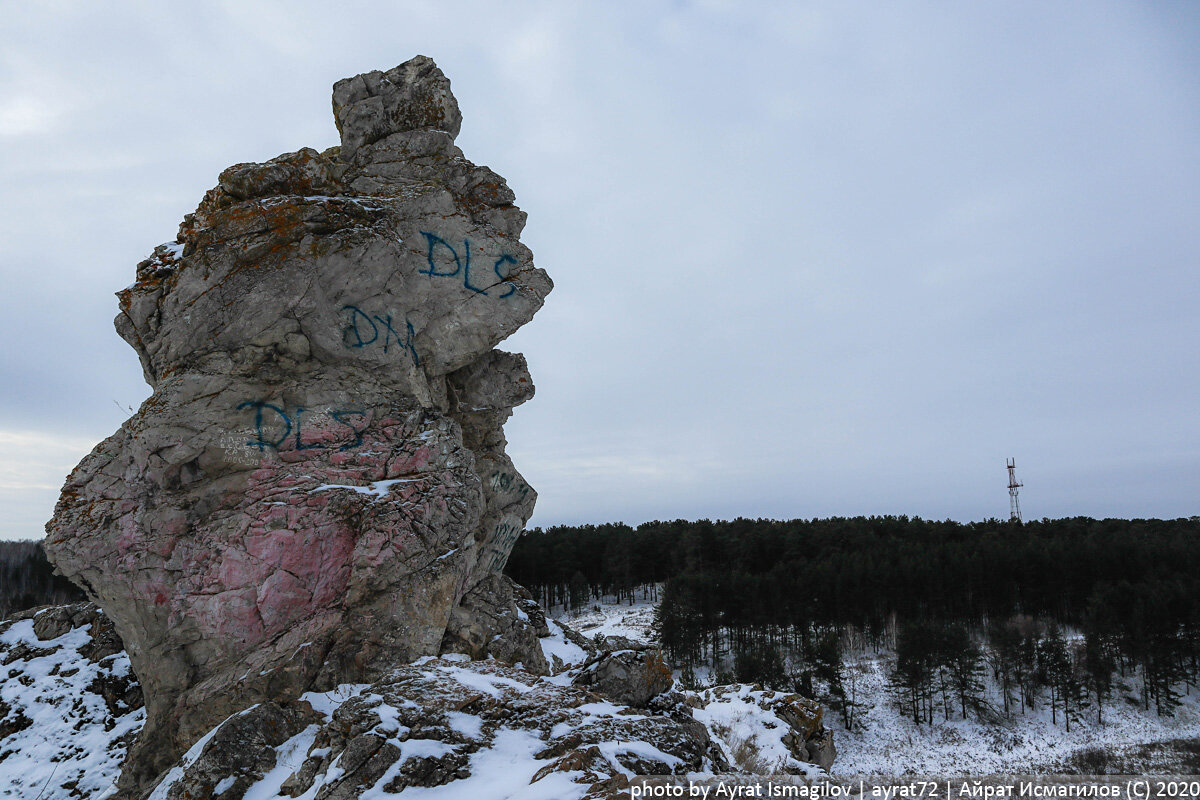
0,0 -> 1200,539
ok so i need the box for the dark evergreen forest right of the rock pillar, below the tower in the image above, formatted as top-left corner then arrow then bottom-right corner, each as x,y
508,517 -> 1200,724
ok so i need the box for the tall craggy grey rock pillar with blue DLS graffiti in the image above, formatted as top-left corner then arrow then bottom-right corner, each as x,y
46,56 -> 552,793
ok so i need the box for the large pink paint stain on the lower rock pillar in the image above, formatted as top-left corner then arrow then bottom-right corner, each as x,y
159,419 -> 462,648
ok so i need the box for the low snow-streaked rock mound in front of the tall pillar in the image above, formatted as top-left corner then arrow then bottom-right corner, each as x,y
156,656 -> 728,800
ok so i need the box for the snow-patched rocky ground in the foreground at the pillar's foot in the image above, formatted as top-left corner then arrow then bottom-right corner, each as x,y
149,655 -> 729,800
